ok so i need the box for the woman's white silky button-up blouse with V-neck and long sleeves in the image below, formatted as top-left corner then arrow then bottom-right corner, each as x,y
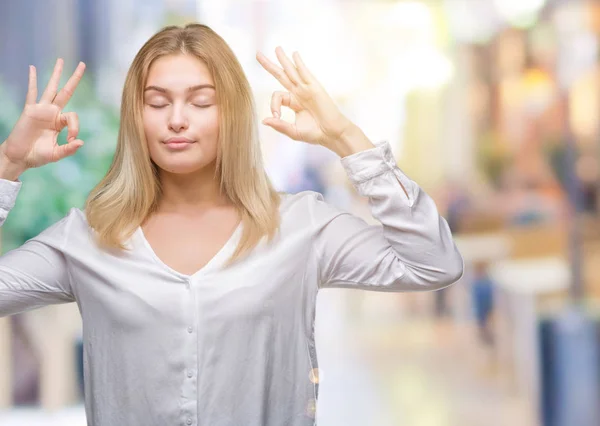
0,142 -> 464,426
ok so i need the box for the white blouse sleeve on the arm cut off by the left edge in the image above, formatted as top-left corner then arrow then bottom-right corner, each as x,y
0,179 -> 75,317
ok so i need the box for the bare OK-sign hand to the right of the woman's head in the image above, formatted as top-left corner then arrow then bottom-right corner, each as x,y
256,47 -> 353,148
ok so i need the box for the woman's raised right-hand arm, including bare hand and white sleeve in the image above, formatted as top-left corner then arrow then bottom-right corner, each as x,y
256,47 -> 463,291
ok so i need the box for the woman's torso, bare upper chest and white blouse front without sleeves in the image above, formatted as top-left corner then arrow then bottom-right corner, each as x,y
63,193 -> 322,426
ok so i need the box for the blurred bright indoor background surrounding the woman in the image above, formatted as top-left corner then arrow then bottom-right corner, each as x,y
0,0 -> 600,426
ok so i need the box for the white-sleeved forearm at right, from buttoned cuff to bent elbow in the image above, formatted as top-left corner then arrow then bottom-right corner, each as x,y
342,143 -> 463,289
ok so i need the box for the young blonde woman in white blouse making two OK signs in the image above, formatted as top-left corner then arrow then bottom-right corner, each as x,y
0,24 -> 463,426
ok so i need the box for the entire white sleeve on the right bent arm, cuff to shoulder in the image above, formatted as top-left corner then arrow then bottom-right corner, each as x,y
312,142 -> 464,292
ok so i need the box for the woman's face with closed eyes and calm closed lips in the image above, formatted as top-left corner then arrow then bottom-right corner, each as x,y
143,54 -> 219,174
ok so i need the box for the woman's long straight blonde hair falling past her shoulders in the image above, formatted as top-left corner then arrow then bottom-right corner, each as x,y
85,23 -> 280,265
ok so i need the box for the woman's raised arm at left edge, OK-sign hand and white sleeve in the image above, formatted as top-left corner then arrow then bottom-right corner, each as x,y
0,59 -> 85,316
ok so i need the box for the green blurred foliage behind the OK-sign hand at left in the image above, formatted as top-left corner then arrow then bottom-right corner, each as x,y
0,68 -> 119,252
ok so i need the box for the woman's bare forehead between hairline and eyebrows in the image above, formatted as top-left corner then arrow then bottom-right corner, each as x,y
146,54 -> 214,91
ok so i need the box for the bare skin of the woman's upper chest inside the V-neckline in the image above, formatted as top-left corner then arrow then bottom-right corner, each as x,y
141,207 -> 240,275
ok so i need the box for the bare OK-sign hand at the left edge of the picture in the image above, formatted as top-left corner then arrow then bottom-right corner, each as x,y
0,58 -> 85,172
